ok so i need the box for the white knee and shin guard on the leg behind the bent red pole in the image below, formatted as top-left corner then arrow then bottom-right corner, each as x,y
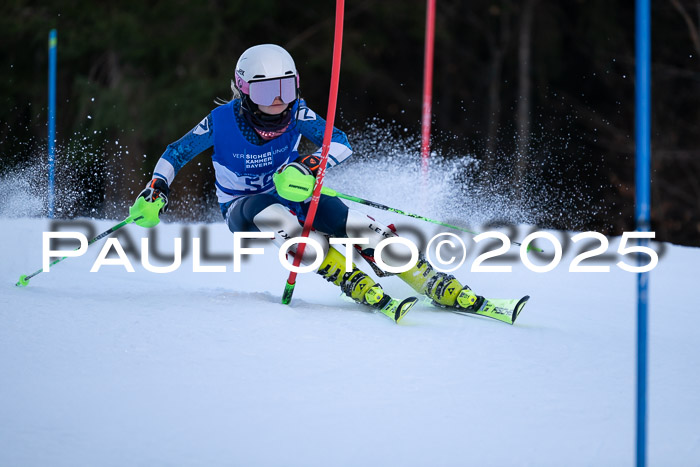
253,204 -> 328,266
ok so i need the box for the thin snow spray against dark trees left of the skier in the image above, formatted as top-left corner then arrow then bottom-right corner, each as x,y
0,122 -> 221,222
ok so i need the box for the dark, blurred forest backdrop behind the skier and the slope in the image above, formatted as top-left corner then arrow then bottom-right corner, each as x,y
0,0 -> 700,245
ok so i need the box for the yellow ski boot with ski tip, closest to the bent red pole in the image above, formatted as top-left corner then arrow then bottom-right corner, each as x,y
317,247 -> 418,323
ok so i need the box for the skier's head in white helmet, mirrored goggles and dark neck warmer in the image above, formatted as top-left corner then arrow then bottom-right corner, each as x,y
232,44 -> 299,131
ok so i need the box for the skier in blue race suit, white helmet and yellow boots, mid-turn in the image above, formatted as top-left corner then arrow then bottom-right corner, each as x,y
131,44 -> 484,322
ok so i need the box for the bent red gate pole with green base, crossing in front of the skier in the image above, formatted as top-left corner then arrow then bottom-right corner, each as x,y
282,0 -> 345,305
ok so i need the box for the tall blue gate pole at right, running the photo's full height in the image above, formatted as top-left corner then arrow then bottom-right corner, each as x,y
635,0 -> 651,467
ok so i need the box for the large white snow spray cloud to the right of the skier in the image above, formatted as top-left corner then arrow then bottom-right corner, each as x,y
336,118 -> 606,234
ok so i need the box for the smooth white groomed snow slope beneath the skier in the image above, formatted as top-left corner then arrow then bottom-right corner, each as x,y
0,218 -> 700,467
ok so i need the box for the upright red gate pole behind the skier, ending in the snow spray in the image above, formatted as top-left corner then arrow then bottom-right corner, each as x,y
421,0 -> 435,184
